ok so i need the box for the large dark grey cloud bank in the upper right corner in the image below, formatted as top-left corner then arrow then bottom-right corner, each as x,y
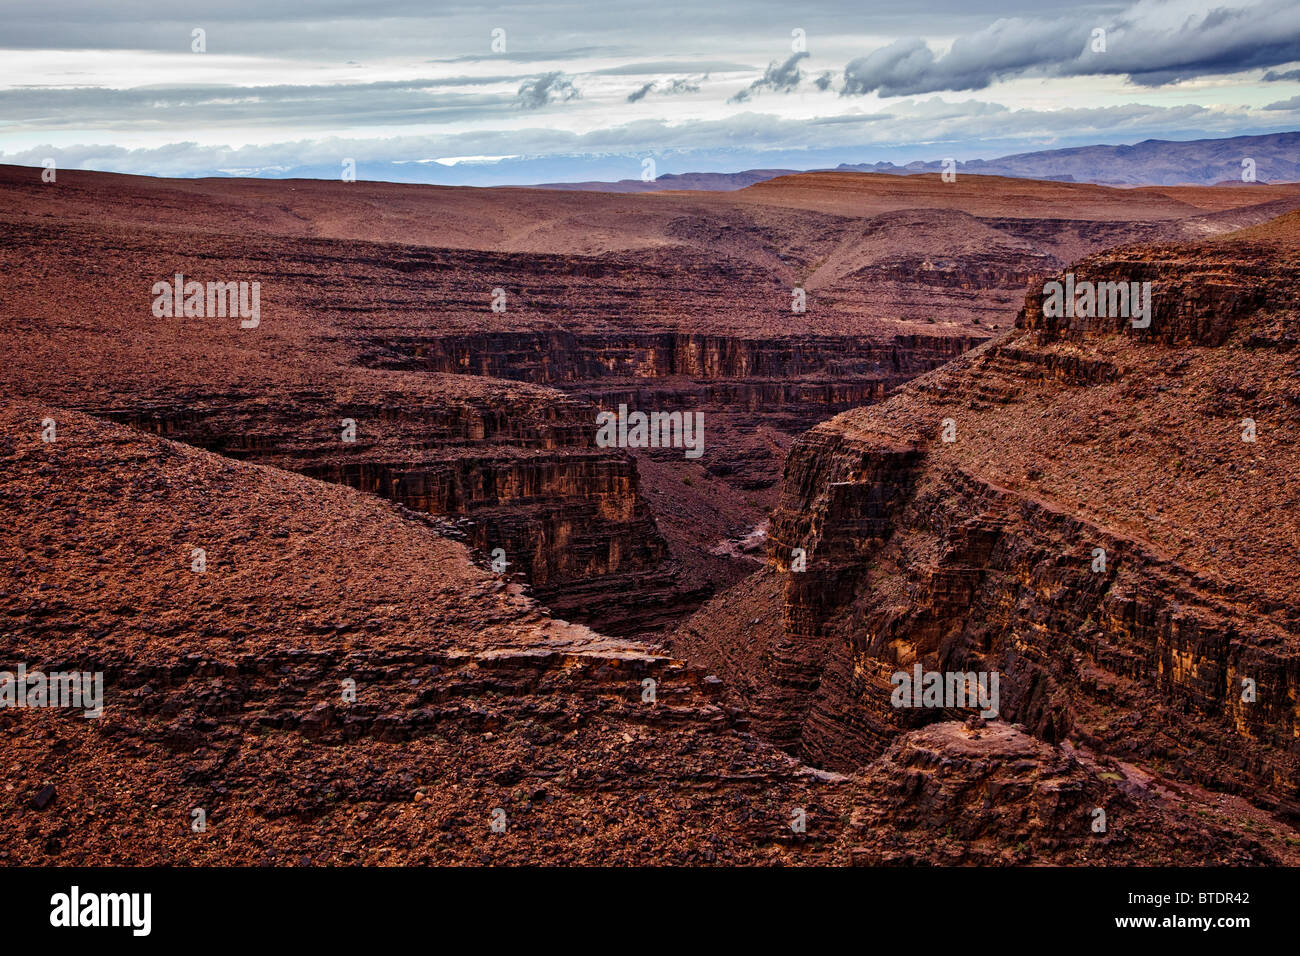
844,0 -> 1300,96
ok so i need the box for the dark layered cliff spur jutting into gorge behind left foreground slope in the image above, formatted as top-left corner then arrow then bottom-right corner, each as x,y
98,390 -> 692,632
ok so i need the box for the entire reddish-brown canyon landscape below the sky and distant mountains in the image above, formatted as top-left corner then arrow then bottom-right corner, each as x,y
0,166 -> 1300,865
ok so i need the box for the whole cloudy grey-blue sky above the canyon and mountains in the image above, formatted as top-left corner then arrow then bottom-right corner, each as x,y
0,0 -> 1300,185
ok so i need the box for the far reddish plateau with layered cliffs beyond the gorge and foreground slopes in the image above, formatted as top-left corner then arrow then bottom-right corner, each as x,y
0,166 -> 1295,633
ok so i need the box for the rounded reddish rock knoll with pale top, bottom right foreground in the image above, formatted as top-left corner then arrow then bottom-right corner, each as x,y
845,721 -> 1262,866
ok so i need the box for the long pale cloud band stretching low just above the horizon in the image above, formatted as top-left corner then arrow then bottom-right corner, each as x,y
0,96 -> 1275,182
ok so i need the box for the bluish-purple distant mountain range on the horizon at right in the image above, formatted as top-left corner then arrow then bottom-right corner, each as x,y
536,131 -> 1300,193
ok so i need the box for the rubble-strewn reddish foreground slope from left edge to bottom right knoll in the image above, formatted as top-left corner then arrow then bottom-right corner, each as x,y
0,402 -> 1287,866
